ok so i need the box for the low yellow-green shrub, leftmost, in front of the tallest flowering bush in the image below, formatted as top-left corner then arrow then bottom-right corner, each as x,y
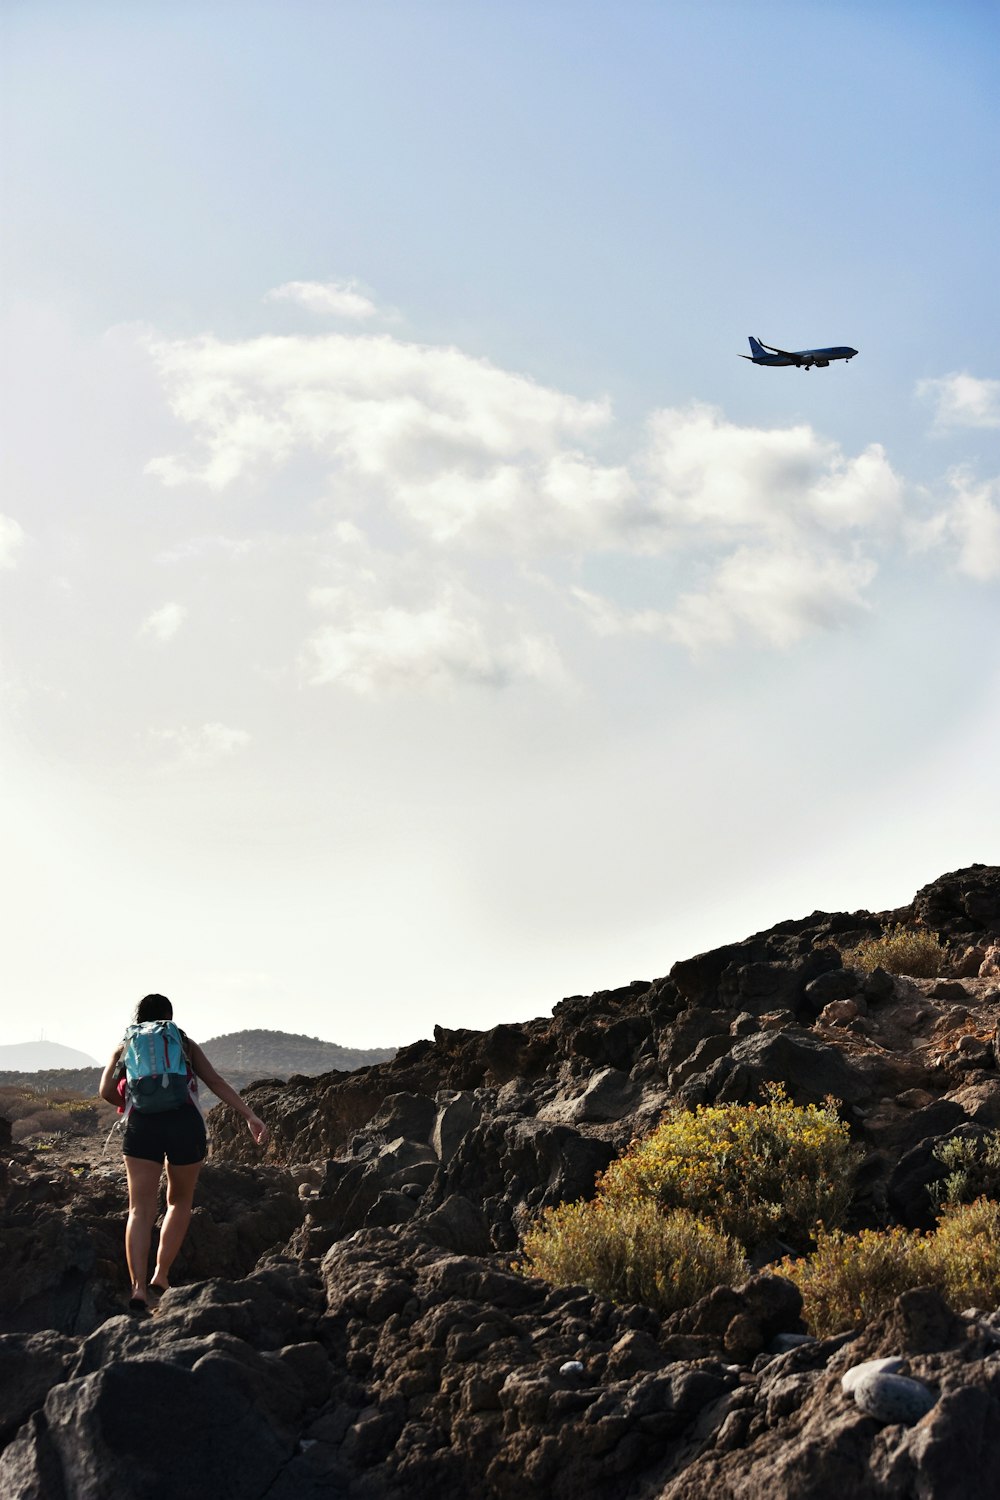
517,1199 -> 748,1314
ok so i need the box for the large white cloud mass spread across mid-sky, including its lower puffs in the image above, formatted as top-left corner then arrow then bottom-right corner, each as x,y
140,322 -> 903,663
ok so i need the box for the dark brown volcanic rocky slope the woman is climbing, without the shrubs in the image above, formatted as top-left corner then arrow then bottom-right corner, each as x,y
0,866 -> 1000,1500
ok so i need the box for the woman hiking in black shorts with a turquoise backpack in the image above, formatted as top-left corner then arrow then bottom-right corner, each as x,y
99,995 -> 268,1313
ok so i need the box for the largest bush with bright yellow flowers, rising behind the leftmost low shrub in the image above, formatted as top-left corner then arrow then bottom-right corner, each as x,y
598,1085 -> 859,1248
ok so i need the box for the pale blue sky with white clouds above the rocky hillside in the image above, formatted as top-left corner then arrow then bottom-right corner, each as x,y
0,0 -> 1000,1058
